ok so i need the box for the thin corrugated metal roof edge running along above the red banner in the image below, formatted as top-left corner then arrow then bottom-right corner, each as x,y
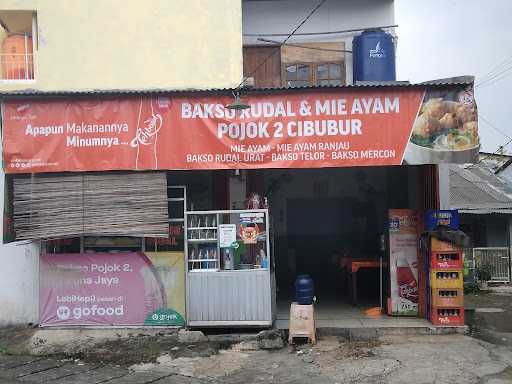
0,76 -> 473,98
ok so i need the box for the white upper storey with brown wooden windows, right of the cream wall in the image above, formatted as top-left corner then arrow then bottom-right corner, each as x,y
242,0 -> 395,87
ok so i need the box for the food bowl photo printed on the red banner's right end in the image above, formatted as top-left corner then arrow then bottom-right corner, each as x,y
404,98 -> 480,164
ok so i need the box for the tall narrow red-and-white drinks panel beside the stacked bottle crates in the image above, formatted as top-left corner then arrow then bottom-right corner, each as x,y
389,209 -> 419,316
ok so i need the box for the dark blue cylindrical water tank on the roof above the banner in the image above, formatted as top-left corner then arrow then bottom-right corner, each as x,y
352,29 -> 396,83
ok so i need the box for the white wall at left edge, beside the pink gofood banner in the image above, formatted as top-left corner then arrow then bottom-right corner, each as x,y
0,160 -> 39,327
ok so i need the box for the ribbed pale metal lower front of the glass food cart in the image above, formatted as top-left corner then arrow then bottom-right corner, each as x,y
187,270 -> 272,325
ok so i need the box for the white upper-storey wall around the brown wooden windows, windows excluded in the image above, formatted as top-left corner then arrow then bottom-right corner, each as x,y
242,0 -> 395,84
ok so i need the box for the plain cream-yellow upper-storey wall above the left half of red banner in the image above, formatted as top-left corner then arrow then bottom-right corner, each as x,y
0,0 -> 242,91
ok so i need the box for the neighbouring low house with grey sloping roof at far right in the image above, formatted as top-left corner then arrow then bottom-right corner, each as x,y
450,165 -> 512,280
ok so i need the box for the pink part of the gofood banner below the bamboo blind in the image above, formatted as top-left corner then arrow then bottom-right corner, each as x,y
39,252 -> 184,326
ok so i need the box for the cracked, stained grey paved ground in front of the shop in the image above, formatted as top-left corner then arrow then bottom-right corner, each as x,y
0,290 -> 512,384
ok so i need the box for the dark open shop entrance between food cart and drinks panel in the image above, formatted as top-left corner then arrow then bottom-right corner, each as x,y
258,167 -> 417,320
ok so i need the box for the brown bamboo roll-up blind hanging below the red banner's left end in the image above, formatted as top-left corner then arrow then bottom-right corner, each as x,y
13,172 -> 169,240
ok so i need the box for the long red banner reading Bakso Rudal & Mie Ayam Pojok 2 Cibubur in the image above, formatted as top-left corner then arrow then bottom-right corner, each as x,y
3,87 -> 479,173
